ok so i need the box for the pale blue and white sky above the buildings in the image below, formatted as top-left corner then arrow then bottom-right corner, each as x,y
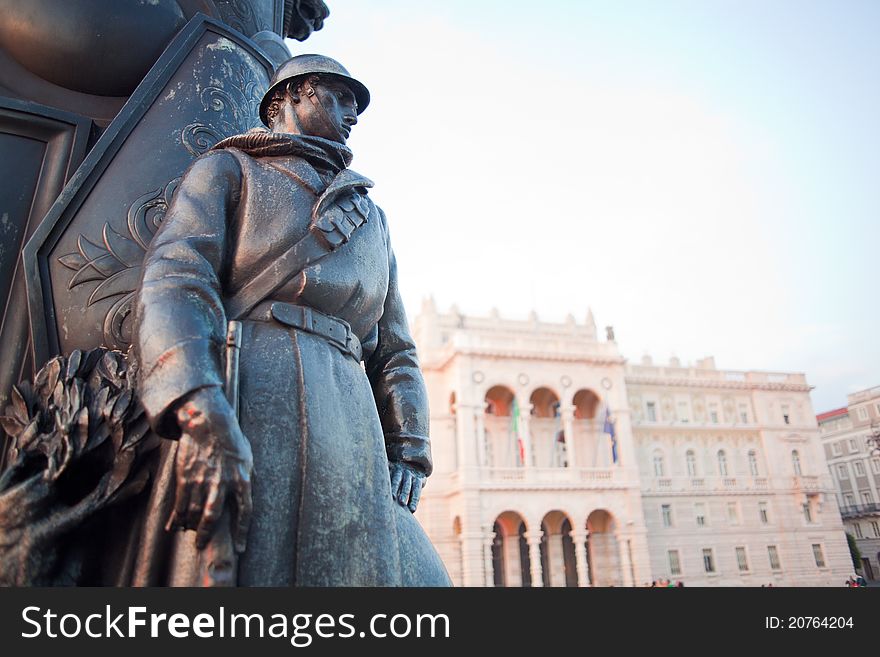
291,0 -> 880,412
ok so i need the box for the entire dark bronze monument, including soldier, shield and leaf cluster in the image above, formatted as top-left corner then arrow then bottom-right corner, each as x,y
0,0 -> 449,585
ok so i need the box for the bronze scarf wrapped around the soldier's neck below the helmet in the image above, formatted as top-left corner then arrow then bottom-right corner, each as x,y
211,130 -> 353,174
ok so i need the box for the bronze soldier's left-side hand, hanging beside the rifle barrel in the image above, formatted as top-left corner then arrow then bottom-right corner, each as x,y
168,387 -> 254,552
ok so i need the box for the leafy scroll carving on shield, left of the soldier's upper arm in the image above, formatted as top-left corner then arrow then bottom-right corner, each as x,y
58,178 -> 180,350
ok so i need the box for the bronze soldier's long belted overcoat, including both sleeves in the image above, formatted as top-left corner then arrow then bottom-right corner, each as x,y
133,135 -> 449,586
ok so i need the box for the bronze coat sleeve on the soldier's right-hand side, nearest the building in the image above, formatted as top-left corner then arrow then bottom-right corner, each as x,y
366,209 -> 433,476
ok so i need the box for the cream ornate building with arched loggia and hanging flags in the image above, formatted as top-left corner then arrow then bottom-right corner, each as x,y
414,301 -> 852,586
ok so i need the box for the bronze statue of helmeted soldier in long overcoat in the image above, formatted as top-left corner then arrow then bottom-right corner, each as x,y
134,55 -> 450,586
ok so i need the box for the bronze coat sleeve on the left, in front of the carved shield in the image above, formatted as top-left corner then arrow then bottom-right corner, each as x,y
133,151 -> 241,438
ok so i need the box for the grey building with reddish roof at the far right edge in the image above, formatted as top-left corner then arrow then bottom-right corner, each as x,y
816,387 -> 880,580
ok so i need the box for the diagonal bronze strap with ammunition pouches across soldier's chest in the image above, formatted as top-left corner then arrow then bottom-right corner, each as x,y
226,169 -> 373,320
